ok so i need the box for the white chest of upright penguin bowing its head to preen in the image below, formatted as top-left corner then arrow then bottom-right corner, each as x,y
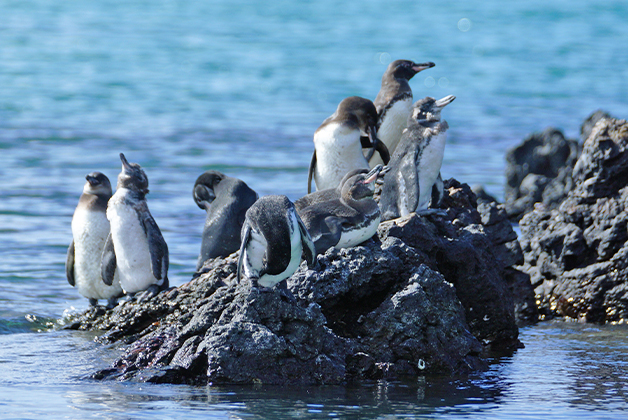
314,123 -> 369,190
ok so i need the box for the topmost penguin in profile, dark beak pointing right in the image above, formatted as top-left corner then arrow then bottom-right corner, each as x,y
367,60 -> 435,168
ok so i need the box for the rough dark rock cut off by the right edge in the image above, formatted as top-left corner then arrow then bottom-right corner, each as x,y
520,118 -> 628,323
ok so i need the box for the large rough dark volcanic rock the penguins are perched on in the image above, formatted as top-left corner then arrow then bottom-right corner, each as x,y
67,180 -> 529,384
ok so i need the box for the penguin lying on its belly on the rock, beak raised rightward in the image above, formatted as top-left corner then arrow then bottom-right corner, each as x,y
299,165 -> 383,254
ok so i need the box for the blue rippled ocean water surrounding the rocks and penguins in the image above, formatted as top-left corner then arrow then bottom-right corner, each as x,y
0,0 -> 628,419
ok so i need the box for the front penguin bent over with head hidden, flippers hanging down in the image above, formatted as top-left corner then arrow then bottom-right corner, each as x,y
237,195 -> 316,290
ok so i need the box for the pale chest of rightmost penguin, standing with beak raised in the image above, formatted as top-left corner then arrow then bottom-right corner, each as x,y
417,132 -> 447,210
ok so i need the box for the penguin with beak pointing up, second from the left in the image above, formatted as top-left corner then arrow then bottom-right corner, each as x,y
102,153 -> 169,297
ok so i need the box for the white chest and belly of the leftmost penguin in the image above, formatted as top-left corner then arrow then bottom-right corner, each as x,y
72,208 -> 122,299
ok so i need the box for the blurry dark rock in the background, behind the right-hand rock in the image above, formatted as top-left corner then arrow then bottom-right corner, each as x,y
504,128 -> 580,221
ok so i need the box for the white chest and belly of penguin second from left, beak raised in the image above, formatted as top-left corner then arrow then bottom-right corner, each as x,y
107,192 -> 157,293
